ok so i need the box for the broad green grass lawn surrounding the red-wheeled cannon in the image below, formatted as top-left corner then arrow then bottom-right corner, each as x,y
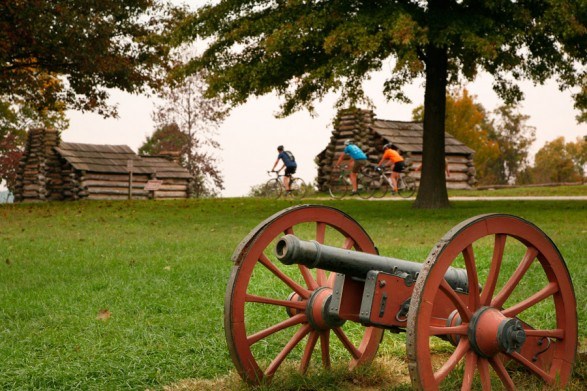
0,199 -> 587,390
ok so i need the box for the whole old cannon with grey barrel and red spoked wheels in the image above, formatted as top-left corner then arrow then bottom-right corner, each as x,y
224,205 -> 578,390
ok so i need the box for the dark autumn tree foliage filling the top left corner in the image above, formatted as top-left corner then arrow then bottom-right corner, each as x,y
0,0 -> 182,116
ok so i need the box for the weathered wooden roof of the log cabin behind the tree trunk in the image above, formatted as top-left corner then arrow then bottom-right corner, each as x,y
370,119 -> 475,155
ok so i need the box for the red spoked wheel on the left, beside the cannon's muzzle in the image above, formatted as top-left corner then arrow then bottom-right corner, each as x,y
224,205 -> 383,384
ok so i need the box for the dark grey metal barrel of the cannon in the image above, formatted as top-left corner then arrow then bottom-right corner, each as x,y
275,235 -> 469,292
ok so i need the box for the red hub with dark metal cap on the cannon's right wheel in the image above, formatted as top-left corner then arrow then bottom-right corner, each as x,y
468,307 -> 526,358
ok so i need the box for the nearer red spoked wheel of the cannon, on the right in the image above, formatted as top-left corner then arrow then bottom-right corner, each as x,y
407,215 -> 577,390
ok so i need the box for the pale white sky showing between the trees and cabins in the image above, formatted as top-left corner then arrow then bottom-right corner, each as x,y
62,71 -> 587,197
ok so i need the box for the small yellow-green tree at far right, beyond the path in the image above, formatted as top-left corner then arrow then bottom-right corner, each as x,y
531,137 -> 582,183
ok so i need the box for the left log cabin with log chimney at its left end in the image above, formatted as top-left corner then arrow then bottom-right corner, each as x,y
14,129 -> 192,202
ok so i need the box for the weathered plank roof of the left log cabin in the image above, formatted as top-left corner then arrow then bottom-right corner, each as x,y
55,142 -> 190,178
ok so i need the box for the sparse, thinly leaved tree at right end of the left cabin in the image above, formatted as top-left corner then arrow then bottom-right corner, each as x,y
139,74 -> 226,197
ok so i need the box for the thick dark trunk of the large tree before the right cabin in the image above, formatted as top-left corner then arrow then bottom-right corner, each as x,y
414,43 -> 450,209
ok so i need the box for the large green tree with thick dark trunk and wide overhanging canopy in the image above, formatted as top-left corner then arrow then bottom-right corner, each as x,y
177,0 -> 587,208
